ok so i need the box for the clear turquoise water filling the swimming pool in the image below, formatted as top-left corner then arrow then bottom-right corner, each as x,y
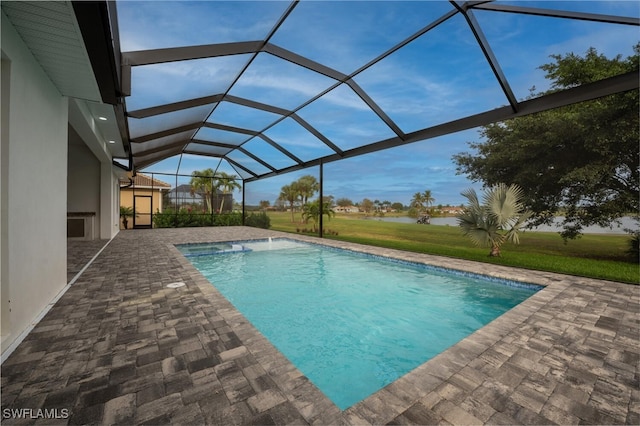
181,240 -> 541,410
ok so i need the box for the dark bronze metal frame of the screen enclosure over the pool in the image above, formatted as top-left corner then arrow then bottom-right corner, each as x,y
112,0 -> 640,233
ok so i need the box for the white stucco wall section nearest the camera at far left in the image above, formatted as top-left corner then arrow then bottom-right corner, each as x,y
0,14 -> 68,353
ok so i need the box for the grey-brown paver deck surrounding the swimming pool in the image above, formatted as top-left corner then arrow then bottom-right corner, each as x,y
2,227 -> 640,425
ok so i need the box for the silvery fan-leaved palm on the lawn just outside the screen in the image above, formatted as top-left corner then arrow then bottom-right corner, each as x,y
458,183 -> 532,256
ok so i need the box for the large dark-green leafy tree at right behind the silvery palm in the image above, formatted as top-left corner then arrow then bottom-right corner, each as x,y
453,44 -> 640,239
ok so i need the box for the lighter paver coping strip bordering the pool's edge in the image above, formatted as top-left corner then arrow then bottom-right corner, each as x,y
167,231 -> 585,424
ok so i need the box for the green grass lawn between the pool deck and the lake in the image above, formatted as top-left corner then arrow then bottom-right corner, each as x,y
262,212 -> 640,284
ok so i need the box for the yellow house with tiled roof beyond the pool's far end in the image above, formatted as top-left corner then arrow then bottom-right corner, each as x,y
120,173 -> 171,229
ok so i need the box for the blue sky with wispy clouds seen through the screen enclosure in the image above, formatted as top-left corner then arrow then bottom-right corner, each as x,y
118,1 -> 640,205
